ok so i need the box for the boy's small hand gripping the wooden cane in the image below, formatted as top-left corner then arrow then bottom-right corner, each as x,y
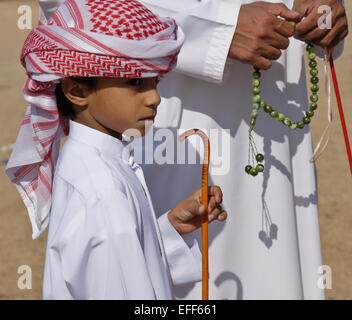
168,186 -> 227,234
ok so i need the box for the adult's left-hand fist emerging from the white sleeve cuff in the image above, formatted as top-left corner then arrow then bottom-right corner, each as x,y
229,1 -> 300,70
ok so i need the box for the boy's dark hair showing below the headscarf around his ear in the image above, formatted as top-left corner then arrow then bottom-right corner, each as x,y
55,77 -> 96,120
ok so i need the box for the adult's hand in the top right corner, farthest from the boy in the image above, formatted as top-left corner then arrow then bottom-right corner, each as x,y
293,0 -> 348,49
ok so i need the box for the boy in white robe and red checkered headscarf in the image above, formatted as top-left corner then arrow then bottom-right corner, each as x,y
7,0 -> 226,299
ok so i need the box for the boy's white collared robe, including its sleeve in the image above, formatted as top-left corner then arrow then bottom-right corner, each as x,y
43,121 -> 201,300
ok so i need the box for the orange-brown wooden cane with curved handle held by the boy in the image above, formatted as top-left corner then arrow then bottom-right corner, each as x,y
179,129 -> 210,300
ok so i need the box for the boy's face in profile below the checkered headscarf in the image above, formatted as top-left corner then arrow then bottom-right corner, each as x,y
65,77 -> 161,138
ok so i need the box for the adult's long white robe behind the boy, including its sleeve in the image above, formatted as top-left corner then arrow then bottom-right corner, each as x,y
39,0 -> 343,299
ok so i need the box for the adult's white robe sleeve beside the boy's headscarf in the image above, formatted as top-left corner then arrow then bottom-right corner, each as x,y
141,0 -> 241,83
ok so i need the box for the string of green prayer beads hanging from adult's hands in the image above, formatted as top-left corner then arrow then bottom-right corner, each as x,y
245,40 -> 319,177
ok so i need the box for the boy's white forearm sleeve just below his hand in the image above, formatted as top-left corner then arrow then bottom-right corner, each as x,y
158,212 -> 202,285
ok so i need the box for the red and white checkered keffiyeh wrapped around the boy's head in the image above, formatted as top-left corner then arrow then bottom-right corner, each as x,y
6,0 -> 184,239
